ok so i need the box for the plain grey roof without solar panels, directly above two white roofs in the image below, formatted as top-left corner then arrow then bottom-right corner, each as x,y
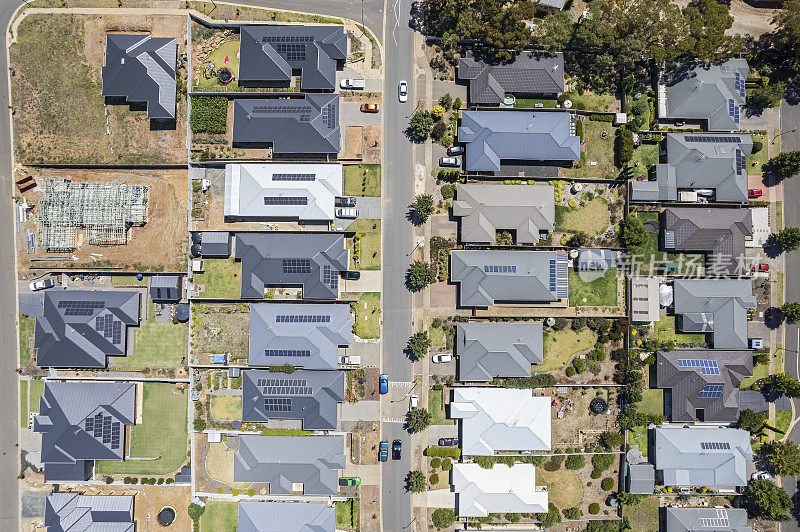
456,321 -> 544,382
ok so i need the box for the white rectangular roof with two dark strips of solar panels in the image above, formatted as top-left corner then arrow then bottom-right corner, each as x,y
225,163 -> 343,221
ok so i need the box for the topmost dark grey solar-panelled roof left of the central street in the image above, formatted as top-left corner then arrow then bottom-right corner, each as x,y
239,24 -> 347,91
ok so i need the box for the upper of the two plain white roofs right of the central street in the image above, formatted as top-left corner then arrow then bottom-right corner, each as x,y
450,388 -> 551,456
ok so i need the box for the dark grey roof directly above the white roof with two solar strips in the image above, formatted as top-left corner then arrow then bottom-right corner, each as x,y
233,94 -> 339,154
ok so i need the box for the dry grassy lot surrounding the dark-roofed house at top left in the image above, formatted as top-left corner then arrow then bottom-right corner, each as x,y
10,14 -> 186,164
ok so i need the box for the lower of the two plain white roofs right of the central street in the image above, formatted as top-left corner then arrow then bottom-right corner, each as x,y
453,463 -> 548,517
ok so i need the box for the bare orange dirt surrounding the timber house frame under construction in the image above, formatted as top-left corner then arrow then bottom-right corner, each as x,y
15,168 -> 188,279
